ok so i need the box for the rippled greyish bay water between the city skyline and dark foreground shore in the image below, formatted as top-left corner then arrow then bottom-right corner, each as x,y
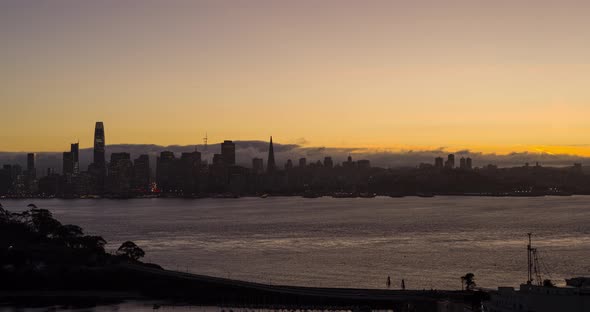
2,196 -> 590,289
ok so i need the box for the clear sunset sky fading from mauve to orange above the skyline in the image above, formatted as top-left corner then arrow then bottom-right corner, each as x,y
0,0 -> 590,155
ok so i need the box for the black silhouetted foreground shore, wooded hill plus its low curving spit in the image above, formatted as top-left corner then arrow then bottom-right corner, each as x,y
0,207 -> 485,311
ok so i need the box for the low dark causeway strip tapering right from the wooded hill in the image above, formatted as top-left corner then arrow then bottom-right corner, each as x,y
114,265 -> 485,311
